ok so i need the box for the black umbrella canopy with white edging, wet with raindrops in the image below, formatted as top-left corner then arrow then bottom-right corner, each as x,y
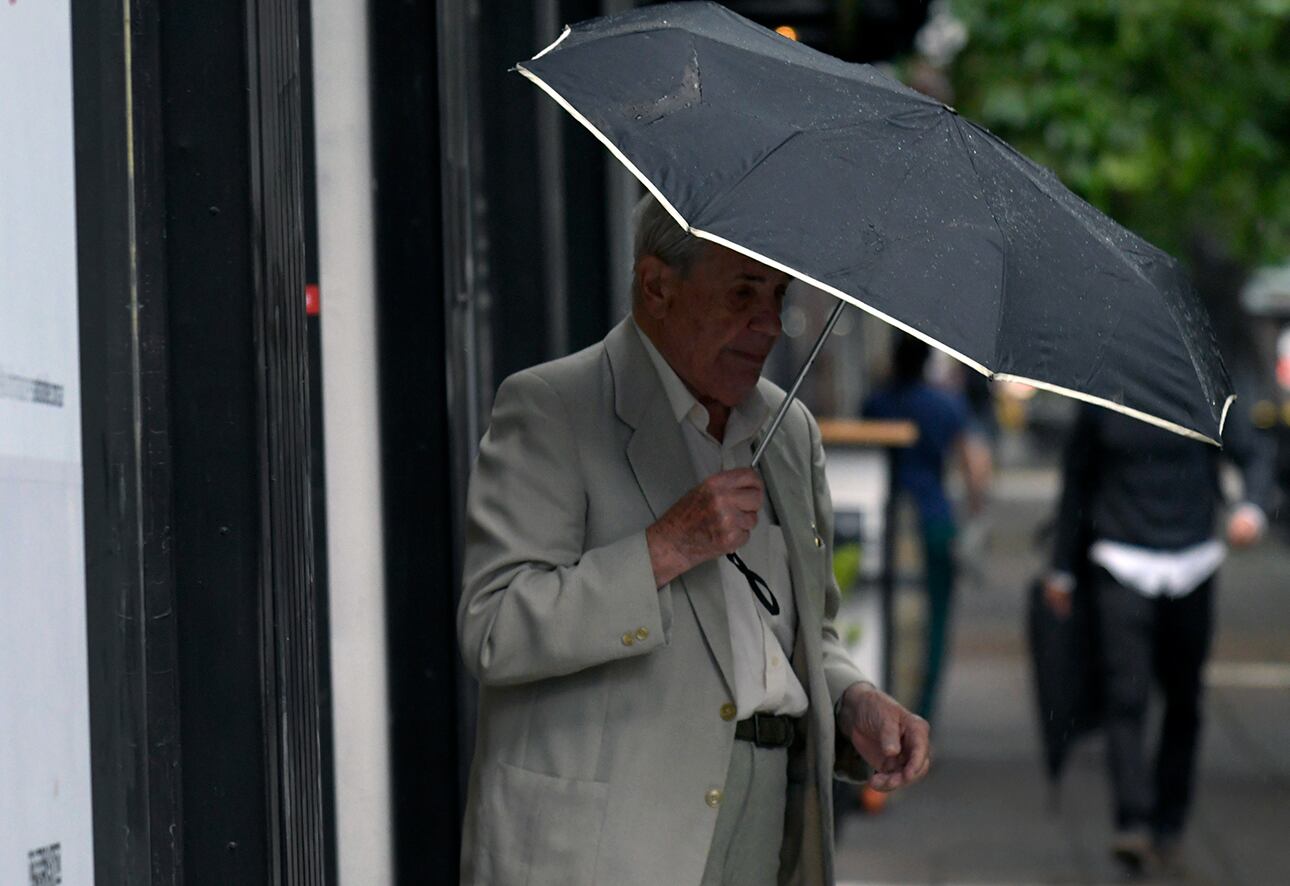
517,3 -> 1232,442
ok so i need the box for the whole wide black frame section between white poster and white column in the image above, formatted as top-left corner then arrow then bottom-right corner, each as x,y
72,0 -> 329,885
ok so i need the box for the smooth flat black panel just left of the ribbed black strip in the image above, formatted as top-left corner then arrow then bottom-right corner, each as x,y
157,3 -> 281,883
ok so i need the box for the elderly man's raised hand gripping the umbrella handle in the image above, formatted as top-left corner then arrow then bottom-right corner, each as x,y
645,468 -> 764,587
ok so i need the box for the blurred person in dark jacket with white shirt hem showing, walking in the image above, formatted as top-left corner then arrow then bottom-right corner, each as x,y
1044,405 -> 1272,872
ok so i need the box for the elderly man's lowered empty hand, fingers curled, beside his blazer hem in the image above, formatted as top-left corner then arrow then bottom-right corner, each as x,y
837,682 -> 931,791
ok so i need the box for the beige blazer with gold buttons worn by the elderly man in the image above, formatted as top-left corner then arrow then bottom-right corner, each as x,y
458,322 -> 864,886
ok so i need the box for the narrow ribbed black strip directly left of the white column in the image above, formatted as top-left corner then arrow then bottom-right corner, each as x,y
245,0 -> 326,883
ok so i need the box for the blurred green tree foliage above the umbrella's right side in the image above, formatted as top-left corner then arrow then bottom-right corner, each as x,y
951,0 -> 1290,264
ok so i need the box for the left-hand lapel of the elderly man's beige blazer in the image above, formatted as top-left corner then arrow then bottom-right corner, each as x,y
605,320 -> 734,698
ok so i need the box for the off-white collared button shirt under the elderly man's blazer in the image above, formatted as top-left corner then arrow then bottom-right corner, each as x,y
632,320 -> 808,720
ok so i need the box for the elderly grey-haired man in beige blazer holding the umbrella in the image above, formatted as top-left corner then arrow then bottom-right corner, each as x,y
458,197 -> 930,886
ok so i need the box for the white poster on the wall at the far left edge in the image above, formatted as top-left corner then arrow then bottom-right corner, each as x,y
0,0 -> 94,886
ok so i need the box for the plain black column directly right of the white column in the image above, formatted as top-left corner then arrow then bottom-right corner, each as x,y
369,0 -> 462,885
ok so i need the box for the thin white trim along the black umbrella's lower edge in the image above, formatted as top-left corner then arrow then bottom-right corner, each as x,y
515,62 -> 1236,449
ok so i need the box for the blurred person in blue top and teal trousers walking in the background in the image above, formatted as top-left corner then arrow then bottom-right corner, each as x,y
860,333 -> 992,721
